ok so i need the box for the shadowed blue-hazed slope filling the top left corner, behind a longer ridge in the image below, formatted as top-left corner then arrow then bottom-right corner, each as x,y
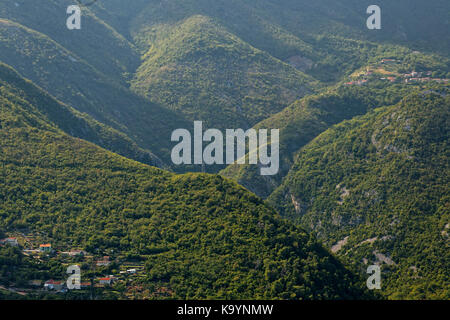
0,0 -> 139,82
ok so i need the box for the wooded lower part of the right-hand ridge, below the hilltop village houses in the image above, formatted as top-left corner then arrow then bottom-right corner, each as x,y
220,84 -> 407,198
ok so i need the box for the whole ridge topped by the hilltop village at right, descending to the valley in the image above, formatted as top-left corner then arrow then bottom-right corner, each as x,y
221,52 -> 450,197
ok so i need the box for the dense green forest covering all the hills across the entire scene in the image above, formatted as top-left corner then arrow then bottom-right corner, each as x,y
0,0 -> 450,300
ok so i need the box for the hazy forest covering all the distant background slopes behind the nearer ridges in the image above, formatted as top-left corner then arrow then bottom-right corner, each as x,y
0,0 -> 448,166
